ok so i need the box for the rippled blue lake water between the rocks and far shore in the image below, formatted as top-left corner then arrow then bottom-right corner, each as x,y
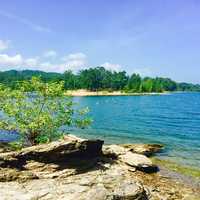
0,93 -> 200,168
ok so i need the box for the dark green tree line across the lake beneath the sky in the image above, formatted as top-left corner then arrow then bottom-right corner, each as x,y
0,67 -> 200,93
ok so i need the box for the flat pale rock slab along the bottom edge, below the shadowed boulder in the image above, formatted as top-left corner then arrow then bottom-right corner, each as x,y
0,165 -> 148,200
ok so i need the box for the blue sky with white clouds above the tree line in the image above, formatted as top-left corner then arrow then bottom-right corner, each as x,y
0,0 -> 200,83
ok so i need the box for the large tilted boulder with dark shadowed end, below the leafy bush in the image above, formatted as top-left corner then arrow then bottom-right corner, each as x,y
0,140 -> 103,169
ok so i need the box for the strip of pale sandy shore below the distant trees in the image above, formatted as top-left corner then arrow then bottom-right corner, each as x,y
65,89 -> 170,97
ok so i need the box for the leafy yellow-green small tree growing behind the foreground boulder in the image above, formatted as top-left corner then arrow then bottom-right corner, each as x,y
0,78 -> 91,145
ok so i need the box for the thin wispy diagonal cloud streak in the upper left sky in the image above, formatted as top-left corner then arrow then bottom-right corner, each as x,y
0,10 -> 52,33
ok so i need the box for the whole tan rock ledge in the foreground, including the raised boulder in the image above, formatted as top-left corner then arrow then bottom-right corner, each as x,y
0,136 -> 200,200
